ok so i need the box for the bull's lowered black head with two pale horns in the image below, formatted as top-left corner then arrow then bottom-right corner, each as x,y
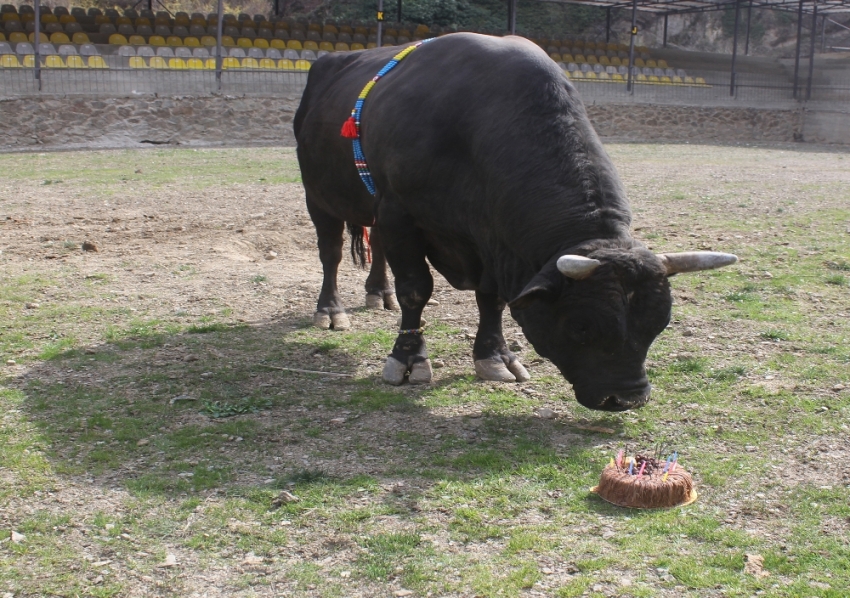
509,247 -> 738,411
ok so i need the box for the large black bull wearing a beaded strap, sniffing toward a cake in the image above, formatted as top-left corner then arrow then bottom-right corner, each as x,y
295,34 -> 735,411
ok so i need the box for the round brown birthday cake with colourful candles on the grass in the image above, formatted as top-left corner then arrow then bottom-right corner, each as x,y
592,451 -> 697,509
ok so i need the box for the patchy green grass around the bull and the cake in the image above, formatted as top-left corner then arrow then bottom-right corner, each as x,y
0,145 -> 850,597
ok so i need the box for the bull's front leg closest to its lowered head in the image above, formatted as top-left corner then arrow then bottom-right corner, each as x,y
472,291 -> 530,382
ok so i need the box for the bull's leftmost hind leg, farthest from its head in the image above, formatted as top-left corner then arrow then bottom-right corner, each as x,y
307,200 -> 351,330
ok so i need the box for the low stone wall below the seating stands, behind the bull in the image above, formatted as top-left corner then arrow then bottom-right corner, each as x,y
0,92 -> 820,151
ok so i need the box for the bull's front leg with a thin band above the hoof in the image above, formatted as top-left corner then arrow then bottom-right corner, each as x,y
377,201 -> 434,385
